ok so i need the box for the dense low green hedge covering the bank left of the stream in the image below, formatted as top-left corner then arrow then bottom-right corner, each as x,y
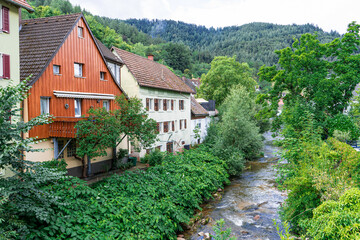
25,149 -> 228,239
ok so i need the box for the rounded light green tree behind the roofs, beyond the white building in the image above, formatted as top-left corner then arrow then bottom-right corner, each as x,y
199,57 -> 256,105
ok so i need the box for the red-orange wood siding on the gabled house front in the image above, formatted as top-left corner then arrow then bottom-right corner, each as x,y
28,19 -> 122,138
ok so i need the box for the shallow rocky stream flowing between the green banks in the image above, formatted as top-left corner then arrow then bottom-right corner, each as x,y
185,133 -> 286,240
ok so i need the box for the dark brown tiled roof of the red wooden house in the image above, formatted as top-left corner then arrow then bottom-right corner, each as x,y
20,13 -> 82,85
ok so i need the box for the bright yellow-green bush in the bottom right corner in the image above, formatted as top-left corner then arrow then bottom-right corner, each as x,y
307,188 -> 360,240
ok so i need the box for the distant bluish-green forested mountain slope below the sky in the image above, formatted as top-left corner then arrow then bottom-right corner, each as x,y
125,19 -> 340,68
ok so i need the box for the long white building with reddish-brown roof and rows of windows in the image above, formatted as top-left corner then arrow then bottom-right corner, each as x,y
112,47 -> 192,157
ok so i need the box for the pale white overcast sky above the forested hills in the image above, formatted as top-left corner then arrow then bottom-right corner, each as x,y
70,0 -> 360,33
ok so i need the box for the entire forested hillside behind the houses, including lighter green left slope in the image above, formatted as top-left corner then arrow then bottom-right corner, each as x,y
23,0 -> 340,78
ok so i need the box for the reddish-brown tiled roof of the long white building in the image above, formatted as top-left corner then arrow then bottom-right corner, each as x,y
112,47 -> 193,93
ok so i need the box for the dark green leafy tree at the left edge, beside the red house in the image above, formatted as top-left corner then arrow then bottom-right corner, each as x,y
0,81 -> 65,238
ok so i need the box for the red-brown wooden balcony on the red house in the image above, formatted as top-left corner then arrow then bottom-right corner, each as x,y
49,117 -> 86,138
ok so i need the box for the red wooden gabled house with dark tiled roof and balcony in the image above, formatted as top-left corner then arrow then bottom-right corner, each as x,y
20,14 -> 126,176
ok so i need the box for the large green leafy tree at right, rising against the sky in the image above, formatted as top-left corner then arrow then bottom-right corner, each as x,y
259,23 -> 360,138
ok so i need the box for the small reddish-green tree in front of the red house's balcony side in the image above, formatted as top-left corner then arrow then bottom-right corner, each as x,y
76,95 -> 157,177
